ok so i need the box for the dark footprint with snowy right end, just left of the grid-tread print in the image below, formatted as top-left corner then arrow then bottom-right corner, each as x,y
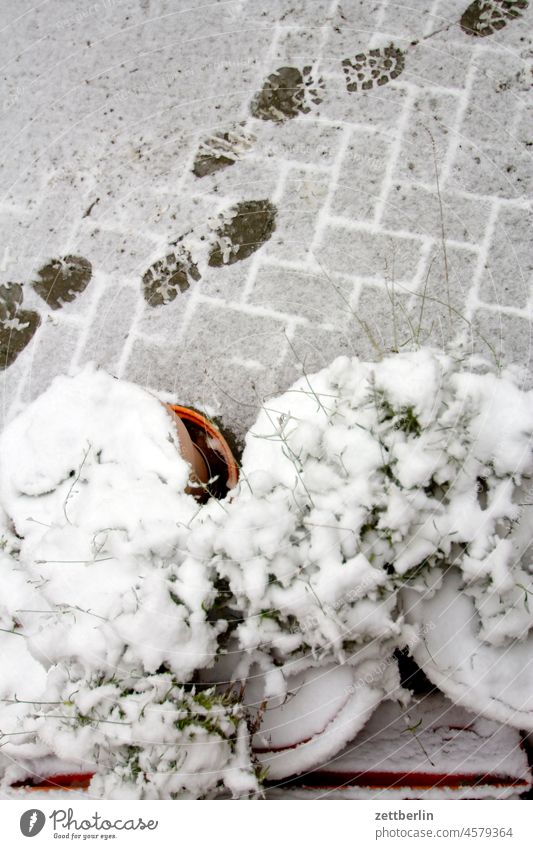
250,65 -> 324,124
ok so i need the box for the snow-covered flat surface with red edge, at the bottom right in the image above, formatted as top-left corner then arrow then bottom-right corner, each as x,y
267,693 -> 532,800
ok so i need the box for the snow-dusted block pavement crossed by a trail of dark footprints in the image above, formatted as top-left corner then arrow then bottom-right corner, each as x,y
0,0 -> 533,444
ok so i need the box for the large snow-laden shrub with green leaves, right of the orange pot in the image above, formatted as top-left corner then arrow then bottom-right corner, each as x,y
187,349 -> 533,692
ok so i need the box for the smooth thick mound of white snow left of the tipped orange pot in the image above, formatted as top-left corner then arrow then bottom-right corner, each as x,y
0,367 -> 225,681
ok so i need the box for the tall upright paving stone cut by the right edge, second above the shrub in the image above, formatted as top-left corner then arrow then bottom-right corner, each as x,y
479,202 -> 533,307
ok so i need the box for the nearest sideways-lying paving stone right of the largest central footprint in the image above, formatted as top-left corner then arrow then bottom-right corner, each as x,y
316,220 -> 420,283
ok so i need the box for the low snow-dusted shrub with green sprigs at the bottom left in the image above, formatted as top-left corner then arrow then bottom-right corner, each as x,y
25,664 -> 259,799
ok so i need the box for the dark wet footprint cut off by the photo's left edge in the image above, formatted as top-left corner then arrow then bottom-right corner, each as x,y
0,283 -> 41,370
